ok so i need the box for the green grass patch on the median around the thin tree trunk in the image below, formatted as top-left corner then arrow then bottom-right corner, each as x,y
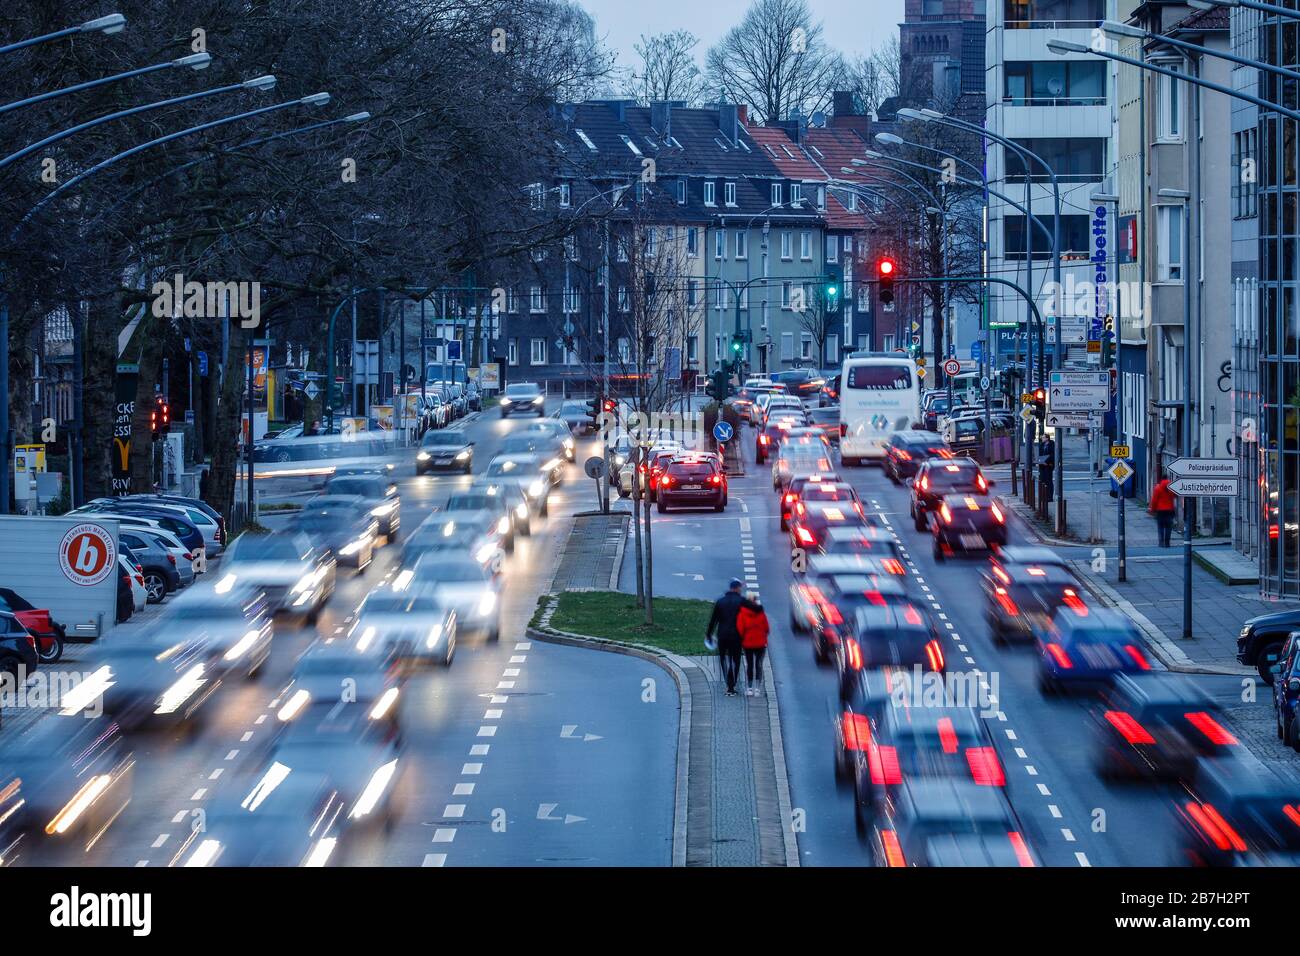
534,591 -> 714,654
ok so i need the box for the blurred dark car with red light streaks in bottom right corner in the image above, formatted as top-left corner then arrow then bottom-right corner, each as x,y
1174,761 -> 1300,866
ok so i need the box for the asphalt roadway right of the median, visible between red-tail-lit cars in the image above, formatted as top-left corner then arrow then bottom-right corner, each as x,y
644,428 -> 1242,866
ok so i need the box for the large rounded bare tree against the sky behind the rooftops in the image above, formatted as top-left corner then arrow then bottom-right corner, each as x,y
705,0 -> 846,121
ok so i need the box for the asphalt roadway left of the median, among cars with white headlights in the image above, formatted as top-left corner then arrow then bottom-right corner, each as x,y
20,414 -> 679,866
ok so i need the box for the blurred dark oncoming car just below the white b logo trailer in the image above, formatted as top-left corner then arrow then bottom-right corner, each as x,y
86,634 -> 221,731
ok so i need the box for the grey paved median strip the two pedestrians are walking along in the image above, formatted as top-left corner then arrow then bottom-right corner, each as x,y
530,512 -> 798,866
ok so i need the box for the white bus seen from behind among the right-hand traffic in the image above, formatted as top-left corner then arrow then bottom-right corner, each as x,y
840,352 -> 920,466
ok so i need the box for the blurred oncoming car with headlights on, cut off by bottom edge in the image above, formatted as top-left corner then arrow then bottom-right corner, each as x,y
179,770 -> 347,866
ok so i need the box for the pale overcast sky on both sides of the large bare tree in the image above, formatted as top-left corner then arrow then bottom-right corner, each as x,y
577,0 -> 904,77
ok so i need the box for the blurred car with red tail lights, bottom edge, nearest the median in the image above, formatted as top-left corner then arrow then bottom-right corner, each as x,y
859,778 -> 1039,868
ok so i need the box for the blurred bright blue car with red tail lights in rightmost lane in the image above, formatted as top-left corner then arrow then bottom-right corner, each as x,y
1036,606 -> 1151,695
